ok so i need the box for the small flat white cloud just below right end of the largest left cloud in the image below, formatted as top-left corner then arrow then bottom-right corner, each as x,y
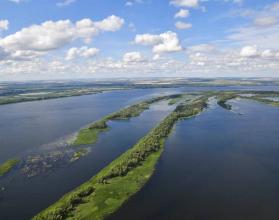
65,47 -> 99,60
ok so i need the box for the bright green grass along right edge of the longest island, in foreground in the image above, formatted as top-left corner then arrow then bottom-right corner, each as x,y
69,149 -> 163,219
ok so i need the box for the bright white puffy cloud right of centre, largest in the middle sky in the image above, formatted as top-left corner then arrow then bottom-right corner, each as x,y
135,31 -> 182,54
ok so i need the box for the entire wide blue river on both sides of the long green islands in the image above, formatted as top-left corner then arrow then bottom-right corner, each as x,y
0,87 -> 279,220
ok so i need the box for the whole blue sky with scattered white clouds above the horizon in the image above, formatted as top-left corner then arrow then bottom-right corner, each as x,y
0,0 -> 279,81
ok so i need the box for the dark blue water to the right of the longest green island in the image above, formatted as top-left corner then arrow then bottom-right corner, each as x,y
112,100 -> 279,220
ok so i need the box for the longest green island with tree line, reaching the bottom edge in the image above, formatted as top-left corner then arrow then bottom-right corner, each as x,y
33,96 -> 208,220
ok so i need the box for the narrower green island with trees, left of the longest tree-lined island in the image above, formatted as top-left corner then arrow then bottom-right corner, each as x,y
73,94 -> 182,146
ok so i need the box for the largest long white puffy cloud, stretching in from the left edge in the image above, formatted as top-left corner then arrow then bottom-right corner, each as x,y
0,15 -> 124,60
